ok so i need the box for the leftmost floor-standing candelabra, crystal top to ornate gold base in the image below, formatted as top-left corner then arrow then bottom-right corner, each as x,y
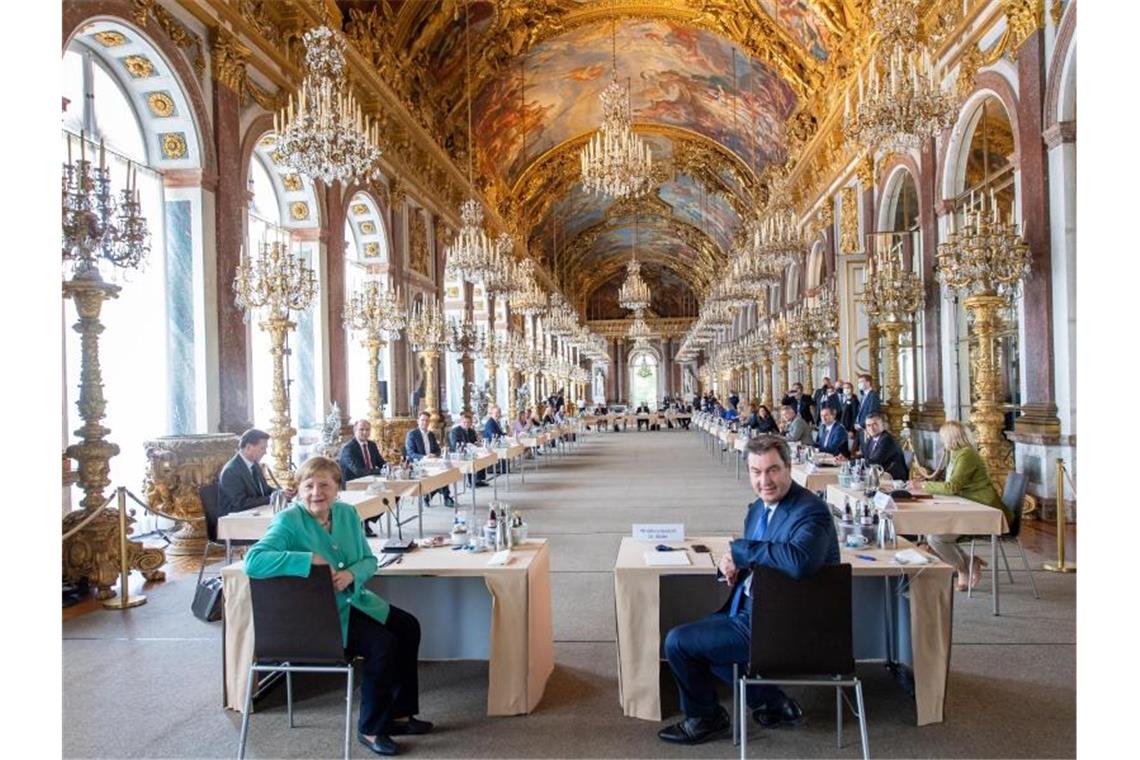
62,133 -> 166,608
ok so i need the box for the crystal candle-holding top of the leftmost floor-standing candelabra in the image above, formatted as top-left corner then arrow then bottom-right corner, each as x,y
63,132 -> 150,279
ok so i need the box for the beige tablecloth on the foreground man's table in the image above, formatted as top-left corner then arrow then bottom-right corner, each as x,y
613,537 -> 953,726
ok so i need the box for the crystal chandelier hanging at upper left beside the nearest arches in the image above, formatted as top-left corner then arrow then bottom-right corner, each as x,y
274,26 -> 380,185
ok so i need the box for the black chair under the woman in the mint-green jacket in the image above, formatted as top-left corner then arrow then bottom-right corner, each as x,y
237,565 -> 352,758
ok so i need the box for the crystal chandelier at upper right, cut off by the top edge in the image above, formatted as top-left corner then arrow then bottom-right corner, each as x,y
844,0 -> 958,153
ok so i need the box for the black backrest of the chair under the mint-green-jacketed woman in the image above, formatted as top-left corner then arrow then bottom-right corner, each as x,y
250,565 -> 344,663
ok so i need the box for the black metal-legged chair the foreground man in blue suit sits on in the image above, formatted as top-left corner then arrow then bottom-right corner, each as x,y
732,564 -> 870,760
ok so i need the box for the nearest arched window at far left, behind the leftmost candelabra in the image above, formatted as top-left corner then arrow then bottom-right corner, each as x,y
60,21 -> 206,524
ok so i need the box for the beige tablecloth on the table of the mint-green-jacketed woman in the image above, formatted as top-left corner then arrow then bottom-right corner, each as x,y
222,539 -> 554,716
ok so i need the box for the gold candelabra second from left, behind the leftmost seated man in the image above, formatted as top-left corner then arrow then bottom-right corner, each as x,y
234,242 -> 317,484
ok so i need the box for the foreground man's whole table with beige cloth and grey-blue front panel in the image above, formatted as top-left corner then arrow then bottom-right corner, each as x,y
613,536 -> 954,726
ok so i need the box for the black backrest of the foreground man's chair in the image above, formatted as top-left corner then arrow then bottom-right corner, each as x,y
749,564 -> 855,678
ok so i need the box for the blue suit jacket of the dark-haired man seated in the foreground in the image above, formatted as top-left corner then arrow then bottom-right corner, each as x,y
730,482 -> 839,620
